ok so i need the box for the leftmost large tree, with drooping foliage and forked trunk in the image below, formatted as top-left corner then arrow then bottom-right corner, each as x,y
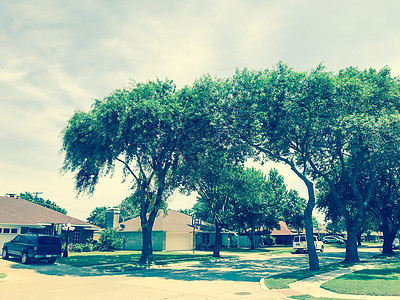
62,80 -> 193,263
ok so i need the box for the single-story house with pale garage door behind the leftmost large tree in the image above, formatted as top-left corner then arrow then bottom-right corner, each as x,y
116,210 -> 230,251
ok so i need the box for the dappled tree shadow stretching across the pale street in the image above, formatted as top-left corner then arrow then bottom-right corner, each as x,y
5,254 -> 343,282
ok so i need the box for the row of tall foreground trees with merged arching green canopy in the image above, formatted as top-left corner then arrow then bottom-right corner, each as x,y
62,62 -> 400,270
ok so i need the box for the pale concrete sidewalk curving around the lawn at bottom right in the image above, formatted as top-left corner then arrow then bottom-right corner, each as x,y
260,261 -> 400,300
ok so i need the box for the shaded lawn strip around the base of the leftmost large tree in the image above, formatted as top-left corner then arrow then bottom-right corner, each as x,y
57,251 -> 222,271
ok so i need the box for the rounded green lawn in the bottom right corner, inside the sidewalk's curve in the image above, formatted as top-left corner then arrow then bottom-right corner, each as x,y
322,262 -> 400,296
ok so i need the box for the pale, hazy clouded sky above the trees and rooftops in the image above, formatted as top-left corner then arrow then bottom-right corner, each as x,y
0,0 -> 400,220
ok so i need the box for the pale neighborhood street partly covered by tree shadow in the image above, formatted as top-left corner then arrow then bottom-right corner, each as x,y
0,248 -> 378,300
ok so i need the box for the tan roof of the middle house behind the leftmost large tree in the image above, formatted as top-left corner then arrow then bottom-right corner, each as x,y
120,209 -> 193,232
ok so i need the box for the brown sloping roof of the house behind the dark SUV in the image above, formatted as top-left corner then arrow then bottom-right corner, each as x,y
0,197 -> 93,227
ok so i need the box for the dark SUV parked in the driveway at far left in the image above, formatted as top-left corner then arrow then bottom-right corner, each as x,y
2,234 -> 61,264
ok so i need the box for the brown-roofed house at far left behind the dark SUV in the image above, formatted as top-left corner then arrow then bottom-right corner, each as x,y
0,196 -> 97,248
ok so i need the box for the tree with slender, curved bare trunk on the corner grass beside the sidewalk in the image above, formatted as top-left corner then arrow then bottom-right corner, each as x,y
226,63 -> 333,270
